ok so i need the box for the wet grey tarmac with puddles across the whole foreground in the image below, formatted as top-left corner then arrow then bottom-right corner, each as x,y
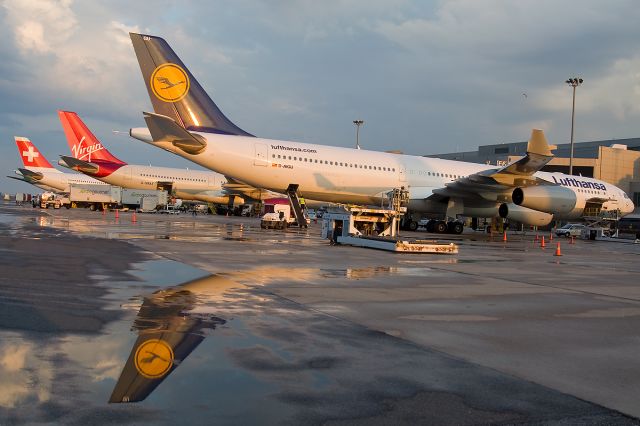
0,204 -> 640,425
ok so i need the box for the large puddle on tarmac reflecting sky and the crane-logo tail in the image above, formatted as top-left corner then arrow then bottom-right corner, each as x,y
0,259 -> 450,424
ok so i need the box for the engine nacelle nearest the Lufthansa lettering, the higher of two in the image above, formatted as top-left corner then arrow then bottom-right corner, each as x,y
511,185 -> 578,214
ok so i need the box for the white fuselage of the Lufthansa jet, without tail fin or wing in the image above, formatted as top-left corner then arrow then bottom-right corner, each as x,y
141,132 -> 634,219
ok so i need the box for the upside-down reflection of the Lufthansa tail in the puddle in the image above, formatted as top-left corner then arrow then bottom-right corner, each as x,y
109,275 -> 244,403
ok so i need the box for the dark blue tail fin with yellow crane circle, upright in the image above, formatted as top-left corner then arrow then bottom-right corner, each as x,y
129,33 -> 253,136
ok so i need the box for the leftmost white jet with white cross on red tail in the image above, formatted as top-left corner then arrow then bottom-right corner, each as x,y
7,136 -> 103,193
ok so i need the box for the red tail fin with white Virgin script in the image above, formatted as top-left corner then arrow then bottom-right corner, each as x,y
58,111 -> 126,164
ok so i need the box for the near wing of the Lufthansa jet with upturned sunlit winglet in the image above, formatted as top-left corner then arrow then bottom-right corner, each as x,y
427,129 -> 555,201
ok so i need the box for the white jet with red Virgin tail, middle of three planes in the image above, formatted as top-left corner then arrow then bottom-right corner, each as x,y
58,111 -> 262,204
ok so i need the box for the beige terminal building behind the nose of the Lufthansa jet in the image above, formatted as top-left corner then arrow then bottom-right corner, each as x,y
426,138 -> 640,211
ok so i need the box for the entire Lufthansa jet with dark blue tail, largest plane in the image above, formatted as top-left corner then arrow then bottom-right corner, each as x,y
129,33 -> 634,233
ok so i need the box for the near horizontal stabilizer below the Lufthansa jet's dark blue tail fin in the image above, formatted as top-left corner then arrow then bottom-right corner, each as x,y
144,112 -> 207,155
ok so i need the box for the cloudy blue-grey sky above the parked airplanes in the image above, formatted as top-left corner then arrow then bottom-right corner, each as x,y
0,0 -> 640,192
